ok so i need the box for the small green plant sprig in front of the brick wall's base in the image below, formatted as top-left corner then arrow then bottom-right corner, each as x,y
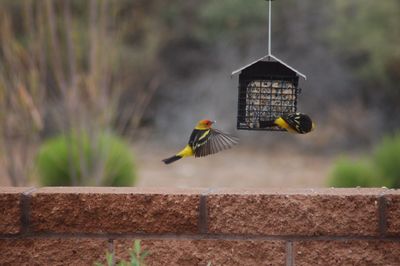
95,240 -> 149,266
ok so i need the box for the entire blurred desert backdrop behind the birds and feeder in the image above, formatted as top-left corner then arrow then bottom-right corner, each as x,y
0,0 -> 400,187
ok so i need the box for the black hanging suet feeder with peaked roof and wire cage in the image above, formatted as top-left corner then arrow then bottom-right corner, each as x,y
232,0 -> 306,131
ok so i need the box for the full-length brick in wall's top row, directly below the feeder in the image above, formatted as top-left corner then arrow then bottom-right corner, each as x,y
207,189 -> 382,236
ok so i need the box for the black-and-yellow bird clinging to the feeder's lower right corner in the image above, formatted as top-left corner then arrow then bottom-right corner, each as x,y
274,113 -> 315,134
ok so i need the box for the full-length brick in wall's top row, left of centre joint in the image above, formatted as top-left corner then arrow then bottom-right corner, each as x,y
31,187 -> 200,233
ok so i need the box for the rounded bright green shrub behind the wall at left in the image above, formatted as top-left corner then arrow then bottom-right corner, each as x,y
36,130 -> 135,186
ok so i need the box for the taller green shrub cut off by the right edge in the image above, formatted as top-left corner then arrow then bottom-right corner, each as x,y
372,133 -> 400,188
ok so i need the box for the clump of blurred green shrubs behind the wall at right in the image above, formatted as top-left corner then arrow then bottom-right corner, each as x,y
328,133 -> 400,188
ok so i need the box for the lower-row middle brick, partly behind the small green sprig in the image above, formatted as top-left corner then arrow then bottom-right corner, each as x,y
115,239 -> 285,266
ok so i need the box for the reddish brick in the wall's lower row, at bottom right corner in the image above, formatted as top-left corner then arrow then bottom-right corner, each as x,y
293,240 -> 400,266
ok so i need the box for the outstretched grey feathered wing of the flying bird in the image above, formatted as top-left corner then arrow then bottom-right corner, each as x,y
194,128 -> 238,157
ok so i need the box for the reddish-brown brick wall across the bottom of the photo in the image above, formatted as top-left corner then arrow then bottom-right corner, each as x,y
0,187 -> 400,265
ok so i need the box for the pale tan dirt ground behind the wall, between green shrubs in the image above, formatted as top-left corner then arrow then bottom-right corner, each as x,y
0,143 -> 336,188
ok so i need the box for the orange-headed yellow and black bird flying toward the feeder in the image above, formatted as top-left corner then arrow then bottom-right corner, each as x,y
163,119 -> 238,164
